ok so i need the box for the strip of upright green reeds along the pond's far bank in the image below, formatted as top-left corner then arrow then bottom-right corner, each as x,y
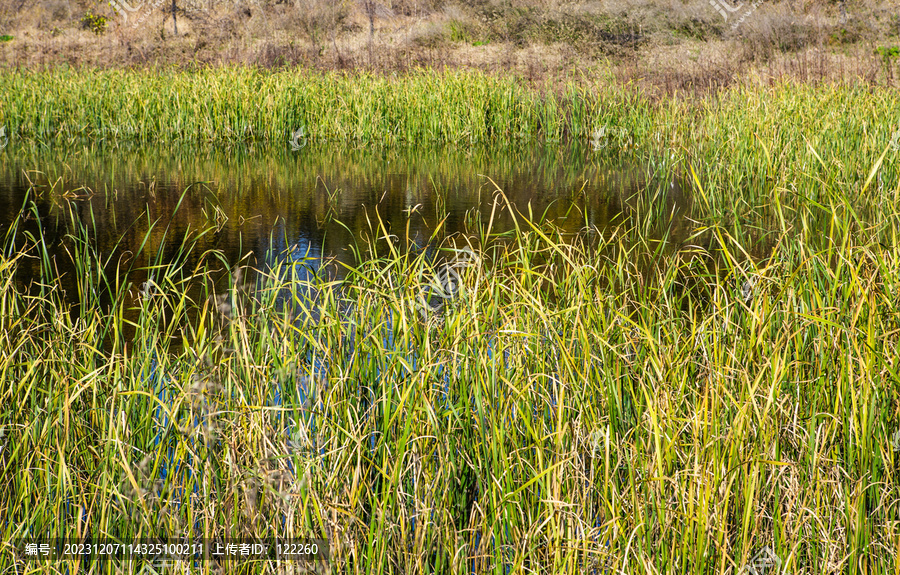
2,68 -> 620,144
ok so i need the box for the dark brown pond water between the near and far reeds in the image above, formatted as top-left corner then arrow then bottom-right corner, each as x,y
0,145 -> 691,285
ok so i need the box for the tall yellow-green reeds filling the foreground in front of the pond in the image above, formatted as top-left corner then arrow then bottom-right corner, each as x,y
0,152 -> 900,573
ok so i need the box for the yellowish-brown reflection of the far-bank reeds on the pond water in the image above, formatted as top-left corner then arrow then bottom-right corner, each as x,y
0,143 -> 665,278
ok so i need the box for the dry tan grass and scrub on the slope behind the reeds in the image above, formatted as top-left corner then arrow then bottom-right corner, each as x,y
0,0 -> 900,93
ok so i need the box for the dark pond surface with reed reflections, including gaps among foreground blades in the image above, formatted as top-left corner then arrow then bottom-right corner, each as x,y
0,144 -> 724,356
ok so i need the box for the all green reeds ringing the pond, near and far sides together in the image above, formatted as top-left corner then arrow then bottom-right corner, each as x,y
0,70 -> 900,574
